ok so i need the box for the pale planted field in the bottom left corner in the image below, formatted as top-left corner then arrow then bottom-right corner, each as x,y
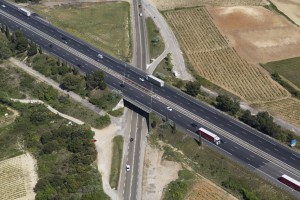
0,154 -> 37,200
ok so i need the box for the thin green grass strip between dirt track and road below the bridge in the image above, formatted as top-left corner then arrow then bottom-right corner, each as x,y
109,135 -> 124,189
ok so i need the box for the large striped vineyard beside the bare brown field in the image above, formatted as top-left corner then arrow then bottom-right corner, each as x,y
164,8 -> 289,102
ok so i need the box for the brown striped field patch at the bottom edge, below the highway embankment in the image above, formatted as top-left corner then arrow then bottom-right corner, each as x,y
185,178 -> 236,200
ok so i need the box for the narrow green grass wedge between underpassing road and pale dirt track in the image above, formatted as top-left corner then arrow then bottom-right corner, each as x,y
146,17 -> 165,59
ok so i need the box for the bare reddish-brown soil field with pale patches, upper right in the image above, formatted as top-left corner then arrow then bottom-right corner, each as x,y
208,6 -> 300,63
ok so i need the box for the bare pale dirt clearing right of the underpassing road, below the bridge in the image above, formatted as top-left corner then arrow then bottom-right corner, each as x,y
142,144 -> 182,200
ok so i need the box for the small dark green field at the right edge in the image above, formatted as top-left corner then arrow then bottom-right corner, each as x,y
262,57 -> 300,88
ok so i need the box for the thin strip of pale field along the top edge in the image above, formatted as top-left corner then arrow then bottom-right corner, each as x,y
151,0 -> 267,10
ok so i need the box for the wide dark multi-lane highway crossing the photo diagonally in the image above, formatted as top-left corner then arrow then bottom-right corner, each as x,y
0,0 -> 300,195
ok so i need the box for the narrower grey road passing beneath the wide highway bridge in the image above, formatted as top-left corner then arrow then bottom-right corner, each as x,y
120,0 -> 148,200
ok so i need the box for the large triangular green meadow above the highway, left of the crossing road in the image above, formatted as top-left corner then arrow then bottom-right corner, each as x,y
30,2 -> 132,61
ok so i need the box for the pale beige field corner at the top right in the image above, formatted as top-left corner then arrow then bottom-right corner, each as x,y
271,0 -> 300,26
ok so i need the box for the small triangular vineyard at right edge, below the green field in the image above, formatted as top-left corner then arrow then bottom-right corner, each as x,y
258,98 -> 300,128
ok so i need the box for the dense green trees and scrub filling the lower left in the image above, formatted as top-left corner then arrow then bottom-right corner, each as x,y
0,97 -> 108,199
